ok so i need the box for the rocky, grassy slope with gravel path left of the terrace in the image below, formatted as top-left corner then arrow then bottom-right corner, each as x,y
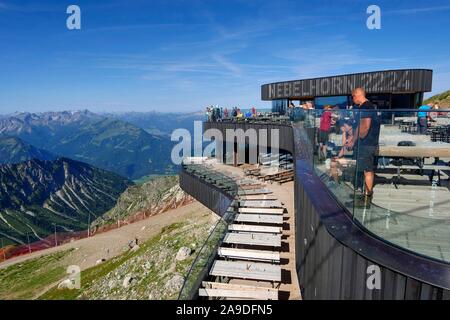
0,202 -> 218,300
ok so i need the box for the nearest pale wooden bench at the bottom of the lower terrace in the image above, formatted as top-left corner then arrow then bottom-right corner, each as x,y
198,281 -> 278,300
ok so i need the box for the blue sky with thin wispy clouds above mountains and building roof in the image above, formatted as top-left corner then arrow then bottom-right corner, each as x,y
0,0 -> 450,113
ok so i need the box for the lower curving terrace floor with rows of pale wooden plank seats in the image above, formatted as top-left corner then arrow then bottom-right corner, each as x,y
181,160 -> 301,300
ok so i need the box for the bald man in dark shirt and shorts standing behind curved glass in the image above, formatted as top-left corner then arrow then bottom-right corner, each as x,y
346,88 -> 380,208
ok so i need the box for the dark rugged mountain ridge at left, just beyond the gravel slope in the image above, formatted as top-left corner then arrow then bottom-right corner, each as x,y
0,158 -> 132,243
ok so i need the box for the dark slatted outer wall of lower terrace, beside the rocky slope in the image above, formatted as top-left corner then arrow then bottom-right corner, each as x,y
180,169 -> 233,217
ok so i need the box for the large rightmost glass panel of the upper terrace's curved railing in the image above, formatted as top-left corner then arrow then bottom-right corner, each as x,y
354,110 -> 450,262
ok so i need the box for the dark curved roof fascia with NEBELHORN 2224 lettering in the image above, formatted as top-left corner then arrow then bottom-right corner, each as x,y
261,69 -> 433,101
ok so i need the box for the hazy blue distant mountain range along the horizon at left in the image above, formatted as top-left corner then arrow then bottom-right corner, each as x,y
0,111 -> 174,179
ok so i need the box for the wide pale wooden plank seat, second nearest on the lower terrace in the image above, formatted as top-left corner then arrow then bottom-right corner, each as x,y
209,260 -> 281,282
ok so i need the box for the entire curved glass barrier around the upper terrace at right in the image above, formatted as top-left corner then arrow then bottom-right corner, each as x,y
292,107 -> 450,262
